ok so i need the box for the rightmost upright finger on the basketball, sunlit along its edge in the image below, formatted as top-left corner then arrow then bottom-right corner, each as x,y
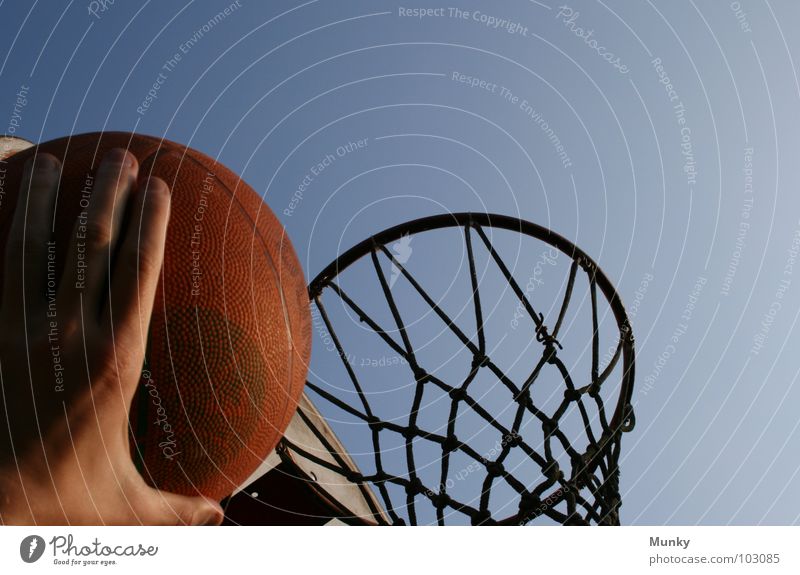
101,178 -> 170,388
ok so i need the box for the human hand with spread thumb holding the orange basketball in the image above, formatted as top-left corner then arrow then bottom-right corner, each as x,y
0,149 -> 223,525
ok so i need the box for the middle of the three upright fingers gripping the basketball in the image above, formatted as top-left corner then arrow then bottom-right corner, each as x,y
63,148 -> 138,317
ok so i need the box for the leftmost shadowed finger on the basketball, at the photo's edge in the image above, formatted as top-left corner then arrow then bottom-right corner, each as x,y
3,154 -> 61,317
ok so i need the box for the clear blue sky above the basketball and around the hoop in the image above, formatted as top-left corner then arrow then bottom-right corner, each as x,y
0,0 -> 800,524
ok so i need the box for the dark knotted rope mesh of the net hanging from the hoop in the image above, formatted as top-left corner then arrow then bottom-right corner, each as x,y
281,214 -> 634,525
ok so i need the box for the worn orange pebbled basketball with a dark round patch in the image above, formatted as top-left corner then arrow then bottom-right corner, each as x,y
0,132 -> 311,500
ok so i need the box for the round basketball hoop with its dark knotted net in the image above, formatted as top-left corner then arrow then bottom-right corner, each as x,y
283,214 -> 634,525
